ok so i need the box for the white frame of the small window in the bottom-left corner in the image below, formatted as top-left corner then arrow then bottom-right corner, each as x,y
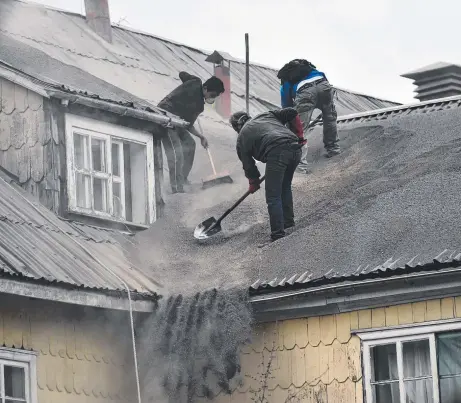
0,348 -> 38,403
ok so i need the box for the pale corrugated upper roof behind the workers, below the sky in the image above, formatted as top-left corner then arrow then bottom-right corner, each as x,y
0,0 -> 396,118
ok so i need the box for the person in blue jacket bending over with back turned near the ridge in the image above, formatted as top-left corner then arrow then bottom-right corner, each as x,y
277,59 -> 341,166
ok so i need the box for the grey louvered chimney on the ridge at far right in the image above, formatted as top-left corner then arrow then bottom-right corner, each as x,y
402,62 -> 461,102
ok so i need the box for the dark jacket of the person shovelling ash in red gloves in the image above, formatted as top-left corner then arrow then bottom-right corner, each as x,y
237,108 -> 302,179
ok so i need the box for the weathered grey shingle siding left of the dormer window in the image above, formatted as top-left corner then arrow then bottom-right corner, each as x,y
0,78 -> 60,212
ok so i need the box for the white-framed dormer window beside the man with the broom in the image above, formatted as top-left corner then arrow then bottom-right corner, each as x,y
66,115 -> 155,225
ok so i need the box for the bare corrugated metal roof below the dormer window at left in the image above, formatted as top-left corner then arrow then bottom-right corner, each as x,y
0,179 -> 164,294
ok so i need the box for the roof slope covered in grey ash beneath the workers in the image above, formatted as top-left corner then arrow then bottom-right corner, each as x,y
130,97 -> 461,296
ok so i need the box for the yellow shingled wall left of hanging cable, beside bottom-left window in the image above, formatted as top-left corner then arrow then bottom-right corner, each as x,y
0,296 -> 135,403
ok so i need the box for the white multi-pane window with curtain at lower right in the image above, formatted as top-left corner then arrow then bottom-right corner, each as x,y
359,322 -> 461,403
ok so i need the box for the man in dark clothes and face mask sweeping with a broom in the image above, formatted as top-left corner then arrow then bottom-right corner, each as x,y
158,71 -> 224,193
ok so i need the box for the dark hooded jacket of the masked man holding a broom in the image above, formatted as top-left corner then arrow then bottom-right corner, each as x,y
158,71 -> 205,126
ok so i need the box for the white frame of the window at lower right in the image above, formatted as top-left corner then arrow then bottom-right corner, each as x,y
356,319 -> 461,403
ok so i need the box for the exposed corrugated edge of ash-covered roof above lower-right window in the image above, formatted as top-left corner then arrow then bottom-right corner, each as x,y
250,250 -> 461,294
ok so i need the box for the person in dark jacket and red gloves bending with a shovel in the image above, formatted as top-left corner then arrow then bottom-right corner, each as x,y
230,108 -> 306,241
